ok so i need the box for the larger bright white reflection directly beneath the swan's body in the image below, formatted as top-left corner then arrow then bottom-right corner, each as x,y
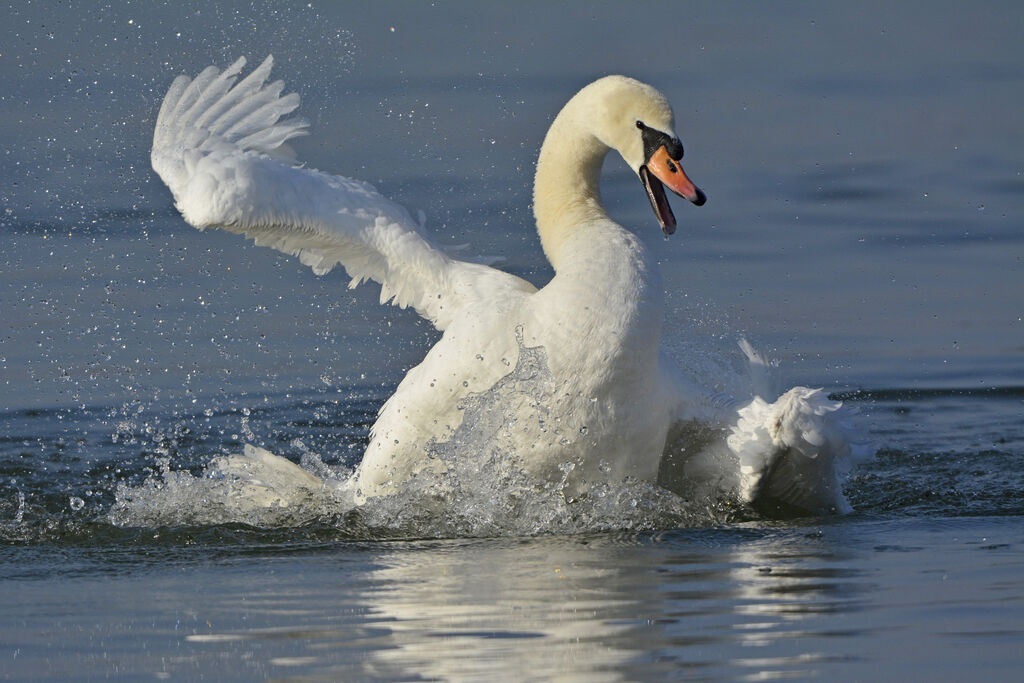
354,541 -> 645,680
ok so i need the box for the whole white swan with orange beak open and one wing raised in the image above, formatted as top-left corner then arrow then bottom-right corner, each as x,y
152,56 -> 868,518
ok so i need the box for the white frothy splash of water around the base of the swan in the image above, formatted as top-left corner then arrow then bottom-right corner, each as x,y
109,335 -> 738,538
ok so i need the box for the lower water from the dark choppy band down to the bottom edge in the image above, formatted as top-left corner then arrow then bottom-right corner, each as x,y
0,391 -> 1024,680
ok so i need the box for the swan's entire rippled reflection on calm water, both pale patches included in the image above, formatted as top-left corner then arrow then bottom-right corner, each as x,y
75,533 -> 866,681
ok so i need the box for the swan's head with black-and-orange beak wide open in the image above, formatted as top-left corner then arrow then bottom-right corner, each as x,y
581,76 -> 708,234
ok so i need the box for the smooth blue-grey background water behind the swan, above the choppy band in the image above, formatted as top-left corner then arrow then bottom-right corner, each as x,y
0,3 -> 1024,409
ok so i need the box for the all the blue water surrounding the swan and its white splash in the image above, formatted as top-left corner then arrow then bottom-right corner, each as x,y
0,3 -> 1024,680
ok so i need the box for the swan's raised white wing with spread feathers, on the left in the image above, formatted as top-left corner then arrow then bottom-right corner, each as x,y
151,56 -> 535,330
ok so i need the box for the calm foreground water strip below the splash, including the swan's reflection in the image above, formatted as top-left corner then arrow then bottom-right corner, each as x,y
0,518 -> 1024,681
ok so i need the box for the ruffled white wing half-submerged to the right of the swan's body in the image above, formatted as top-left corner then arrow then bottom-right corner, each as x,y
727,387 -> 871,516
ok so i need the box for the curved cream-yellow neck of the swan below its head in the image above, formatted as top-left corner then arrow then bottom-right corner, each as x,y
534,107 -> 609,271
